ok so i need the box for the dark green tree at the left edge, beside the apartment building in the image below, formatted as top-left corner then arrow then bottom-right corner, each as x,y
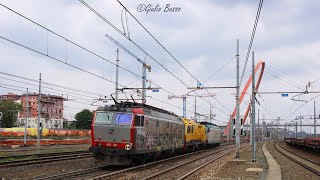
0,99 -> 23,128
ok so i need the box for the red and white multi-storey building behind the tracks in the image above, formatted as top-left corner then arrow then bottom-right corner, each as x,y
19,93 -> 64,129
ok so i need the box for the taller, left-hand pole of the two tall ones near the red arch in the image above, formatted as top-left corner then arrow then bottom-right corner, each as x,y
236,39 -> 240,159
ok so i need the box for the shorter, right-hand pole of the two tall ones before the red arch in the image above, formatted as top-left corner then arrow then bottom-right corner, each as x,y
251,51 -> 256,162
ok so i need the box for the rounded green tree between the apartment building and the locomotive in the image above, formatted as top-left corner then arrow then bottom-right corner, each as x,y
75,109 -> 93,129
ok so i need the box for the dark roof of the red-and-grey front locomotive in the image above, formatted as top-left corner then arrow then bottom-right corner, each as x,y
97,102 -> 179,117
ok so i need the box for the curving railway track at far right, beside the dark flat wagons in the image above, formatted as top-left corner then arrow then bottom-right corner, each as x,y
273,142 -> 320,176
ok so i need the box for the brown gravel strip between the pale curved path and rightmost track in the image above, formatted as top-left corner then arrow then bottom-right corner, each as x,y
266,142 -> 319,180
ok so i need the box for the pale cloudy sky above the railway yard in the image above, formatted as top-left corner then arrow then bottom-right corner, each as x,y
0,0 -> 320,134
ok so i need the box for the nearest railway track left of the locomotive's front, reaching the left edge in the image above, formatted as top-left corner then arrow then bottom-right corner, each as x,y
0,151 -> 92,168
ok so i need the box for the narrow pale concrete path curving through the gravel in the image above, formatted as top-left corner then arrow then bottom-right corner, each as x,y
262,144 -> 281,180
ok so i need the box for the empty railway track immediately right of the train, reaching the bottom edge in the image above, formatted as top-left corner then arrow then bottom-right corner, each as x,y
85,145 -> 240,180
